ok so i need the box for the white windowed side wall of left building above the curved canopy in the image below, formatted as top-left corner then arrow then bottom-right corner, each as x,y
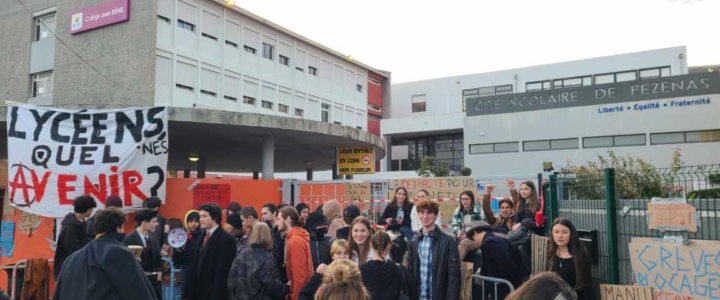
155,0 -> 368,130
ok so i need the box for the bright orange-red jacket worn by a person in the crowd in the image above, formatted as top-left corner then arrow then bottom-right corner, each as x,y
285,227 -> 315,300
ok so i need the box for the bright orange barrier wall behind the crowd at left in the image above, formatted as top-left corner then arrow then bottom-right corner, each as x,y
0,178 -> 284,295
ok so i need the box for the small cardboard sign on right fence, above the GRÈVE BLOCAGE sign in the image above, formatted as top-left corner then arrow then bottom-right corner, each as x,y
648,202 -> 697,232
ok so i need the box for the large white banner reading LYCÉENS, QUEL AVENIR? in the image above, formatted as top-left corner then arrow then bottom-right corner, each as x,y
7,104 -> 168,217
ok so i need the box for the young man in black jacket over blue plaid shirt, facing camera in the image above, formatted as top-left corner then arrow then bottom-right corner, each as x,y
408,200 -> 462,300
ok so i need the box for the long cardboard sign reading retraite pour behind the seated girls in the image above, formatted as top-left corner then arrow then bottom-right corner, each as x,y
387,177 -> 477,199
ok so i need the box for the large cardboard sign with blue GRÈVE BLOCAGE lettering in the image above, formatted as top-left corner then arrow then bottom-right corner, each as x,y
629,238 -> 720,300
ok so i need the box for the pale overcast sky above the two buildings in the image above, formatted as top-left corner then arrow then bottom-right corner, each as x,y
236,0 -> 720,83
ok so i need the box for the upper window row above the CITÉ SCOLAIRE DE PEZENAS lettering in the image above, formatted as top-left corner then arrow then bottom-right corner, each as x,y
525,66 -> 671,92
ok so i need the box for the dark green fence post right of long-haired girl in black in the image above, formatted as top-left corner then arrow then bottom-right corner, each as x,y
605,168 -> 620,284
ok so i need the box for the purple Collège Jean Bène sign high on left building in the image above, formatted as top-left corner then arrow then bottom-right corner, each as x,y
70,0 -> 130,34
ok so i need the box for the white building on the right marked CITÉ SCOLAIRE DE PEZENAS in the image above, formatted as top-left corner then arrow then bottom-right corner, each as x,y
381,47 -> 720,176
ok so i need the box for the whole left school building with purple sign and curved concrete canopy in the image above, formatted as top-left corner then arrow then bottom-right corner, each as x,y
0,0 -> 390,178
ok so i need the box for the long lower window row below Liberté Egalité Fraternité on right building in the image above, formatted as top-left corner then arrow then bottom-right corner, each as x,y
469,129 -> 720,154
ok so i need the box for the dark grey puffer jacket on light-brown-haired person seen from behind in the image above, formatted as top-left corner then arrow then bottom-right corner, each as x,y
227,247 -> 288,300
